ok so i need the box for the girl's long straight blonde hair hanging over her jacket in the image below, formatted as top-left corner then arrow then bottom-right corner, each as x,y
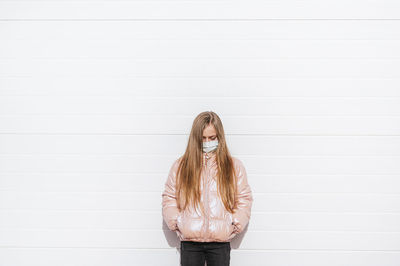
176,111 -> 237,213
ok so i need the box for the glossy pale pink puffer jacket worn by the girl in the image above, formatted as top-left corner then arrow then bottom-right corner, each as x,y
162,152 -> 253,242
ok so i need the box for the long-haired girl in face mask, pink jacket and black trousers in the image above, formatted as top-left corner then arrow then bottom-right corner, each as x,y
162,112 -> 253,266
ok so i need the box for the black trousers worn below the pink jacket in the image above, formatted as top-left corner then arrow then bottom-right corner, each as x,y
181,241 -> 231,266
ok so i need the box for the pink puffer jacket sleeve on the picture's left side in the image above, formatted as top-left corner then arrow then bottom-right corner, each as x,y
162,160 -> 179,231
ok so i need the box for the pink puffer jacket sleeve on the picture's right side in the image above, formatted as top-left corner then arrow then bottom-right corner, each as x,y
232,159 -> 253,234
